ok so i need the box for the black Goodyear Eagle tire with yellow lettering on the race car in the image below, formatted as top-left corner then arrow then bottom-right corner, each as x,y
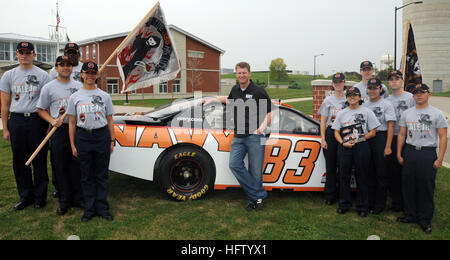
158,146 -> 216,201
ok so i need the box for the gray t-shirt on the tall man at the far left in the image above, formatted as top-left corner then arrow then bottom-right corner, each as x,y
0,66 -> 50,113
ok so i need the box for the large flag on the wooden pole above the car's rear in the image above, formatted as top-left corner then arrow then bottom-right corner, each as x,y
117,3 -> 181,93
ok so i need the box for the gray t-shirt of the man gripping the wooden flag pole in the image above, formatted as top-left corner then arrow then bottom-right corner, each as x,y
37,79 -> 83,123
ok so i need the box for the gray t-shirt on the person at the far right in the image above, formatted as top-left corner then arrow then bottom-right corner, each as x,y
399,106 -> 448,147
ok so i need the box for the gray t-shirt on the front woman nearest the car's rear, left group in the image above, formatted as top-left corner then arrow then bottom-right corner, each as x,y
67,88 -> 114,130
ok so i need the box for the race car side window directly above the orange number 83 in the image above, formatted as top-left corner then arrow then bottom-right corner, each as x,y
272,109 -> 320,135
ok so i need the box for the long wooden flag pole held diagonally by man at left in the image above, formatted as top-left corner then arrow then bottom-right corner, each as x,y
25,2 -> 159,166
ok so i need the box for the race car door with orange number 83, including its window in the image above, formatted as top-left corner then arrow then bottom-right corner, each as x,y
263,106 -> 326,191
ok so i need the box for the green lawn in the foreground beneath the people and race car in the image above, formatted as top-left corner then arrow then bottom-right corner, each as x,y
0,130 -> 450,240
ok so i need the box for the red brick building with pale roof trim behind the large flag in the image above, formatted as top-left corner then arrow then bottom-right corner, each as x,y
78,25 -> 225,98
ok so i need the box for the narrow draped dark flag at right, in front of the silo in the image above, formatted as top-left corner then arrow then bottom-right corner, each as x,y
402,22 -> 422,91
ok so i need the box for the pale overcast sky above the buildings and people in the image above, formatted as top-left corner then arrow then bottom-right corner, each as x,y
0,0 -> 402,75
